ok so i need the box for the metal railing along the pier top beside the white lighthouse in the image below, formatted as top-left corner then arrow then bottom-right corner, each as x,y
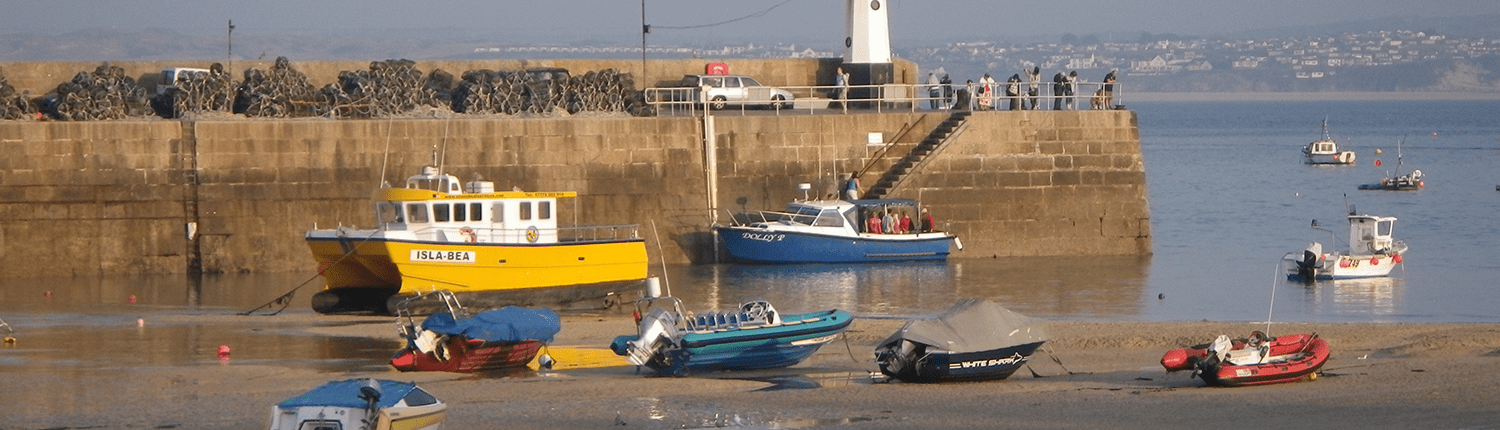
644,81 -> 1124,115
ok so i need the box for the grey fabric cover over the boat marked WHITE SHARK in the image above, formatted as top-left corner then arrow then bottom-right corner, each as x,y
881,298 -> 1050,354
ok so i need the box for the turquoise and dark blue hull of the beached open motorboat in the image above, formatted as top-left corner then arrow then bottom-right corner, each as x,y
611,310 -> 852,375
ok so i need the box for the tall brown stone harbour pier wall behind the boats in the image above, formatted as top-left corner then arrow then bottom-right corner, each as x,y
0,111 -> 1151,277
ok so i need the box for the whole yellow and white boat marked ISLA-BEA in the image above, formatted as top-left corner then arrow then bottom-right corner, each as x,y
306,166 -> 647,313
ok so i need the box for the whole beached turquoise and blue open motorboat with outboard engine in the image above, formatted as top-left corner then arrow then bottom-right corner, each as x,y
609,297 -> 854,375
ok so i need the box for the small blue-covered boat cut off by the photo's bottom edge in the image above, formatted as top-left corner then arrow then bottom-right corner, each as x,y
270,379 -> 449,430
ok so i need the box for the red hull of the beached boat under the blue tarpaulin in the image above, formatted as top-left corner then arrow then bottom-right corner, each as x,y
390,337 -> 542,373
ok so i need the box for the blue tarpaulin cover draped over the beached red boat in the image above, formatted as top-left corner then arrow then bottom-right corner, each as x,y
422,306 -> 563,342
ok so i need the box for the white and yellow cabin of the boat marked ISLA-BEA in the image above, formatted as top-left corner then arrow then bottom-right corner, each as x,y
375,166 -> 575,243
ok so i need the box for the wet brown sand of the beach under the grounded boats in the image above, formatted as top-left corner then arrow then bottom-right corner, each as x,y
0,315 -> 1500,429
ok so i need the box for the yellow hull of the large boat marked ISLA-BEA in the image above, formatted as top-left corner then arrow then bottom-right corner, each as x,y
306,231 -> 648,313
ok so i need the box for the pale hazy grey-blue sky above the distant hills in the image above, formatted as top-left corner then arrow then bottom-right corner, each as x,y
0,0 -> 1500,47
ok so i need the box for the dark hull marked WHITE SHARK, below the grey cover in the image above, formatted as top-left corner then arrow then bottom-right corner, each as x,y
881,342 -> 1043,382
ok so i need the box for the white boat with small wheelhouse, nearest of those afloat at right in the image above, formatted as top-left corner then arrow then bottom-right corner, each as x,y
1283,211 -> 1407,282
